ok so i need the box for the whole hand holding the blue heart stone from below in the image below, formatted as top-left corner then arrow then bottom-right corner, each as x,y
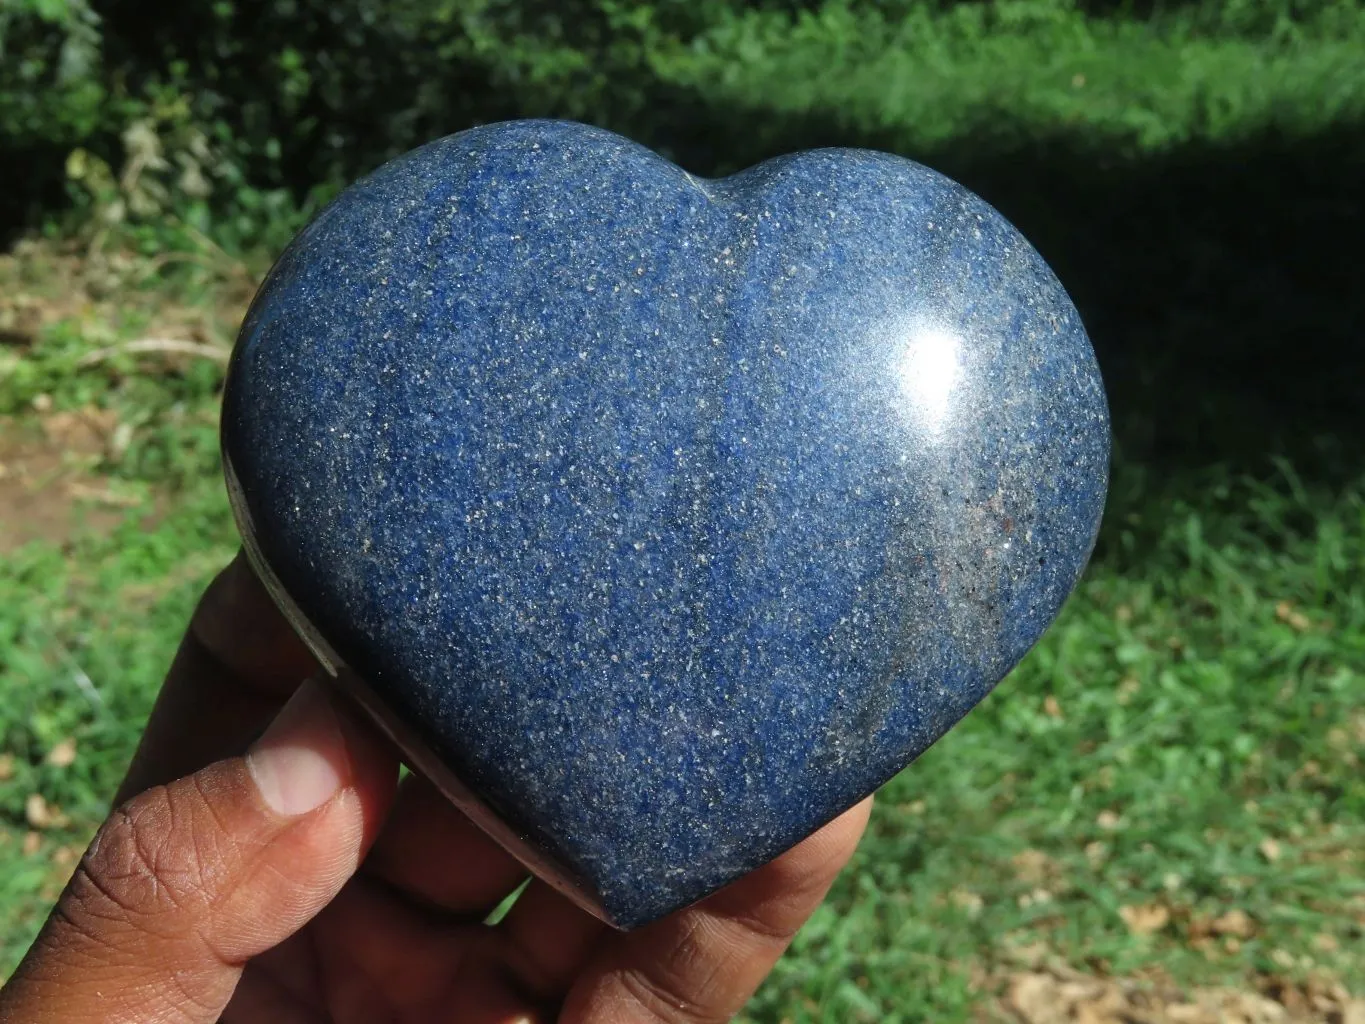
0,558 -> 868,1024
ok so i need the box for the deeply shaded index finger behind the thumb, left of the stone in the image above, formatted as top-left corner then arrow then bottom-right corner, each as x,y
115,554 -> 318,804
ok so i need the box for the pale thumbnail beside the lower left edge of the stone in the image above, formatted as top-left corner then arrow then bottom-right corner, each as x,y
247,679 -> 347,818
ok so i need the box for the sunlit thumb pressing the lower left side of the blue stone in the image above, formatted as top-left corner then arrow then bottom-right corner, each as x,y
0,681 -> 397,1024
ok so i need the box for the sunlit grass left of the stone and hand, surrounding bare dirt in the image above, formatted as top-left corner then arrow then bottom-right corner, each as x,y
0,246 -> 242,973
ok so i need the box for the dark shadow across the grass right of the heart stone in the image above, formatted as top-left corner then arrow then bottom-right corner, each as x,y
638,97 -> 1365,494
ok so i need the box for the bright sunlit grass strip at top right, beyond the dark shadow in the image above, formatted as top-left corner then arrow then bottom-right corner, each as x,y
654,0 -> 1365,160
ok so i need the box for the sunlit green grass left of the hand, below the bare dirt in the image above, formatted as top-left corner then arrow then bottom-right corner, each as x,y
0,486 -> 235,973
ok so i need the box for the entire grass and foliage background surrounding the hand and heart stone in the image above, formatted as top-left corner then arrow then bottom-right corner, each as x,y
0,0 -> 1365,1024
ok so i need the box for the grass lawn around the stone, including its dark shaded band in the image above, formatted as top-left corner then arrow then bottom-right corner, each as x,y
0,3 -> 1365,1024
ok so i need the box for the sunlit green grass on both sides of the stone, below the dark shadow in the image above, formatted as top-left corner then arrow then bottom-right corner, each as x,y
0,247 -> 1365,1021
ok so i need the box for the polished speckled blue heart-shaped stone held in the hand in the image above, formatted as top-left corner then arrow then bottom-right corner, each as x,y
224,122 -> 1108,927
